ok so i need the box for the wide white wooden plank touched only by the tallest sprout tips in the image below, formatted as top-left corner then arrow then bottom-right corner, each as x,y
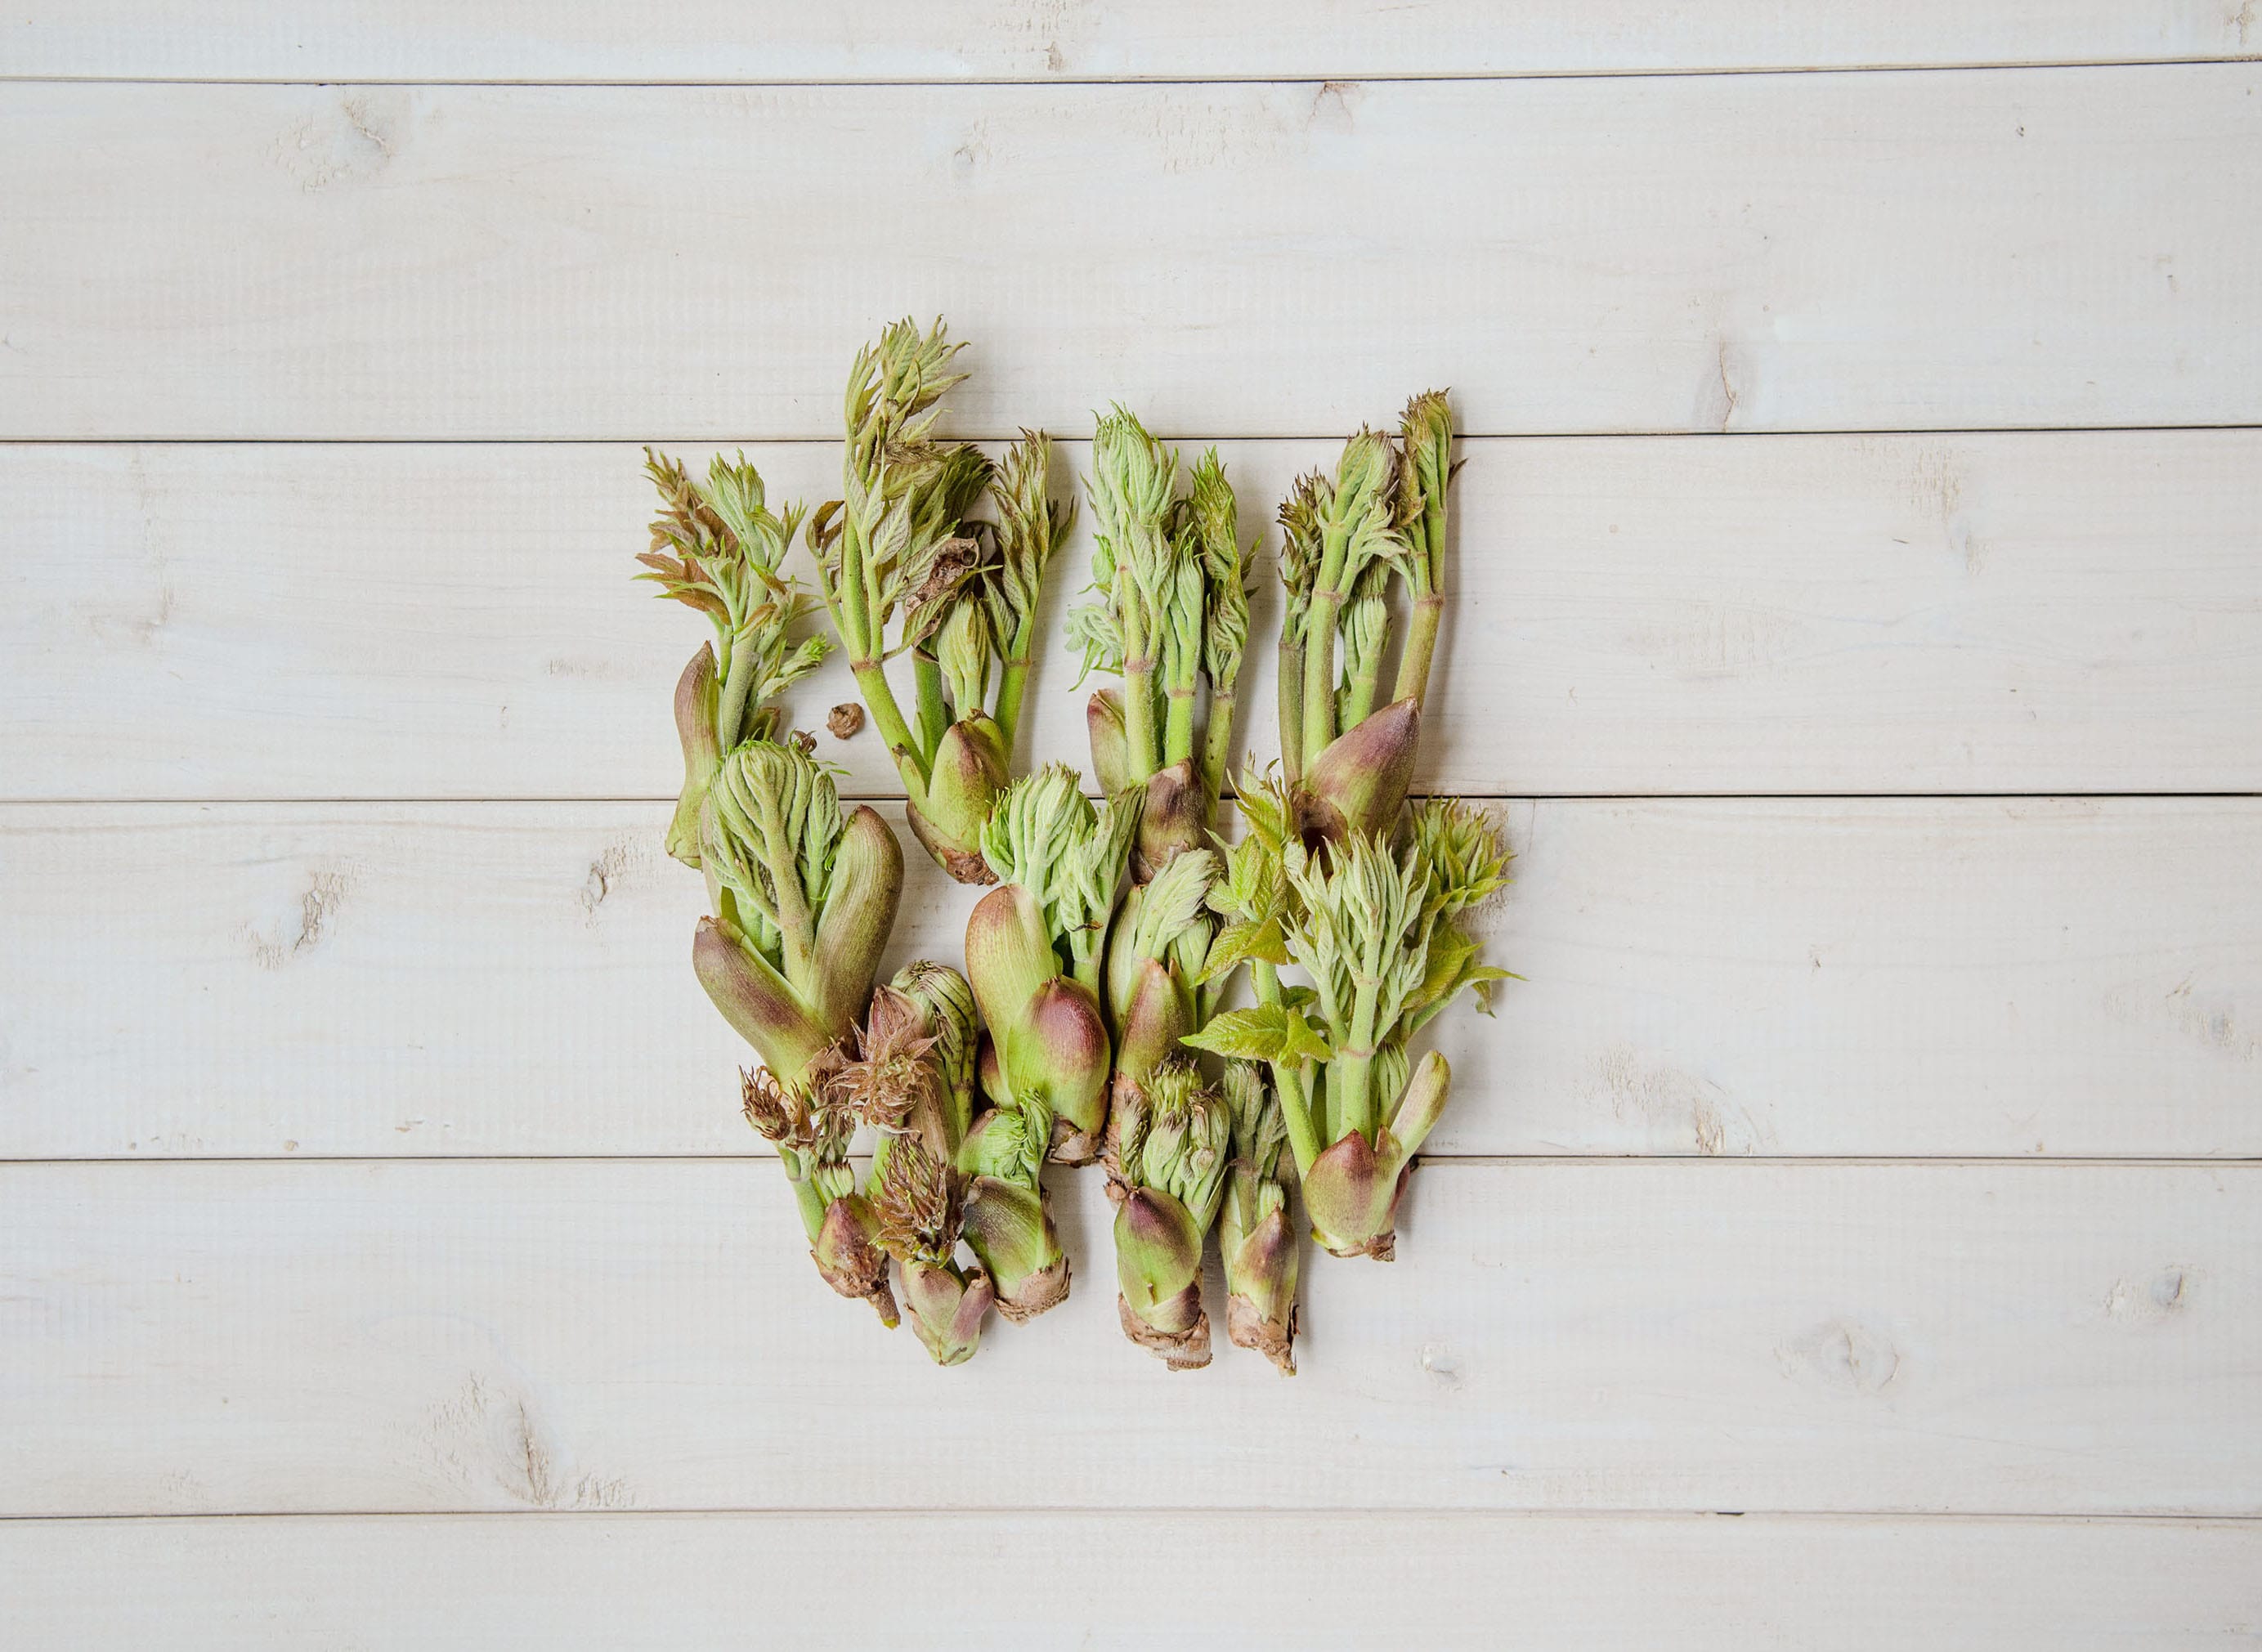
0,64 -> 2262,439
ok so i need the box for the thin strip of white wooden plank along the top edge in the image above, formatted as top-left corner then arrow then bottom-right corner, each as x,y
0,0 -> 2262,82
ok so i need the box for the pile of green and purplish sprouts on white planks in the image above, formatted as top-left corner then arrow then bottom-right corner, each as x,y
640,321 -> 1507,1373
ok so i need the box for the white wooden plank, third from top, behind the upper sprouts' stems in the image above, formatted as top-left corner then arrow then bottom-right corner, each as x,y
17,432 -> 2262,799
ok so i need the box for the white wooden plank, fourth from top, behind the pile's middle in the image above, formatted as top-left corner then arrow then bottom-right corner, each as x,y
0,799 -> 2262,1158
